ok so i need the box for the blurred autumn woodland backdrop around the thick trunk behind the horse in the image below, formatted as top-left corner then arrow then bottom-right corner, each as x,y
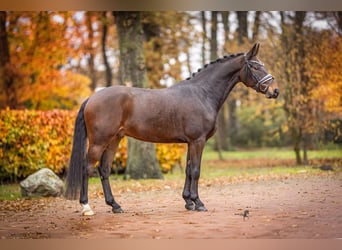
0,11 -> 342,163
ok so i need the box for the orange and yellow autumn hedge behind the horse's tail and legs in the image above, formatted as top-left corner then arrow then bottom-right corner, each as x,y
0,109 -> 185,181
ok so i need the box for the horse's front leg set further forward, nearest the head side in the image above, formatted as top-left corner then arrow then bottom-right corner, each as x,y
184,139 -> 207,211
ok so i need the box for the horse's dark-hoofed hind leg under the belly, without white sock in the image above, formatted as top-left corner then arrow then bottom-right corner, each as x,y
99,136 -> 124,213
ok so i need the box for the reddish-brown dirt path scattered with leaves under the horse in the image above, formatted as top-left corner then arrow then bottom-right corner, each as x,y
0,172 -> 342,239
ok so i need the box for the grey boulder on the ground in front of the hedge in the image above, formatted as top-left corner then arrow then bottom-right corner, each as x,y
20,168 -> 64,197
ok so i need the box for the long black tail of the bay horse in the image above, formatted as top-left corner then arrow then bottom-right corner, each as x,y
65,99 -> 88,200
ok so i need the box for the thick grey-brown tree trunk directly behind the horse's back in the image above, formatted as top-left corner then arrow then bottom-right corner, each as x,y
113,11 -> 163,179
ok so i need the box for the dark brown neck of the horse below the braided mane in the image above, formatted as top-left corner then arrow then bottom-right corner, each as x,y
201,57 -> 242,112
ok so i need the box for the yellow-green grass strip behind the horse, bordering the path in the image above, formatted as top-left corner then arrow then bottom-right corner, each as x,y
0,148 -> 342,201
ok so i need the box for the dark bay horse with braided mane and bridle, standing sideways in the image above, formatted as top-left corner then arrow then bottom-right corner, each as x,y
66,44 -> 279,215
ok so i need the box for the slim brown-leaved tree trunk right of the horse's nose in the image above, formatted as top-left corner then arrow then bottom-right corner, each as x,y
280,11 -> 310,165
